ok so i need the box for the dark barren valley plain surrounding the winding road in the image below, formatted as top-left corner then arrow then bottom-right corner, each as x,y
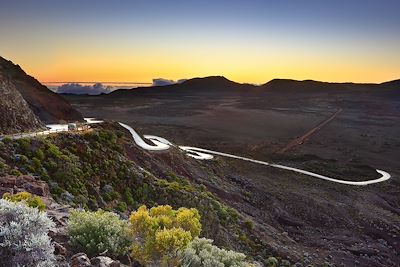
66,78 -> 400,266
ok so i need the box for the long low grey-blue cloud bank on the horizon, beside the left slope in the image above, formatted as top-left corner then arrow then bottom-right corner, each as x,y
56,83 -> 115,95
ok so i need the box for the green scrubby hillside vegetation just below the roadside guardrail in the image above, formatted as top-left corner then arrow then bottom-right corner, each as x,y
0,129 -> 240,243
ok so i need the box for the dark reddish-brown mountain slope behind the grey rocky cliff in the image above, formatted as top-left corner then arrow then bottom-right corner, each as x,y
0,57 -> 83,123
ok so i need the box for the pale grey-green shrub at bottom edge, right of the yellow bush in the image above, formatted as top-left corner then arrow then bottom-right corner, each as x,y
180,238 -> 254,267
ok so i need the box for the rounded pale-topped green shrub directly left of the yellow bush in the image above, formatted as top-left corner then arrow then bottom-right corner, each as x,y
67,210 -> 131,257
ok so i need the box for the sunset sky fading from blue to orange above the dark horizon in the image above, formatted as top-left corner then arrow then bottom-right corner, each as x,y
0,0 -> 400,84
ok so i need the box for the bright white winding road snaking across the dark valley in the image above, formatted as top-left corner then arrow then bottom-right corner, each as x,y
119,122 -> 391,185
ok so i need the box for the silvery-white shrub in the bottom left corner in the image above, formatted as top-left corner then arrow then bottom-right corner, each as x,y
0,199 -> 55,267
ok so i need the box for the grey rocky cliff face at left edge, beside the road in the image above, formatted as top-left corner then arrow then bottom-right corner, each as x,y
0,73 -> 44,135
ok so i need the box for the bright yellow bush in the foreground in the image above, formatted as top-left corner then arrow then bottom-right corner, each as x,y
129,205 -> 201,266
